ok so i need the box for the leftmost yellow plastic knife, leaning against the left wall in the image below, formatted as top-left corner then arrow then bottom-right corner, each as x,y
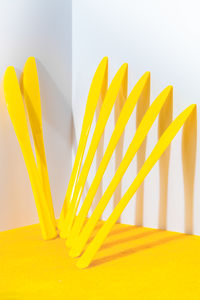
3,67 -> 57,239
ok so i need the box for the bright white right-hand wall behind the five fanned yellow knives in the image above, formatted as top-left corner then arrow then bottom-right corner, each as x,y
72,0 -> 200,234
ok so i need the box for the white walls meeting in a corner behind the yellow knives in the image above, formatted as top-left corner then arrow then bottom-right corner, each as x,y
0,0 -> 200,234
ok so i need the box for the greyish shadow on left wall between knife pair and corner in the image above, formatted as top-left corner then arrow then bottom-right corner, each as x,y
36,60 -> 73,216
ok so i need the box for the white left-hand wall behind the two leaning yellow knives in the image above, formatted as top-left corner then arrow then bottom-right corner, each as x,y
0,0 -> 72,230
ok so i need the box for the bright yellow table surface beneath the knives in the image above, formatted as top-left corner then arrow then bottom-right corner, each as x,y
0,224 -> 200,300
